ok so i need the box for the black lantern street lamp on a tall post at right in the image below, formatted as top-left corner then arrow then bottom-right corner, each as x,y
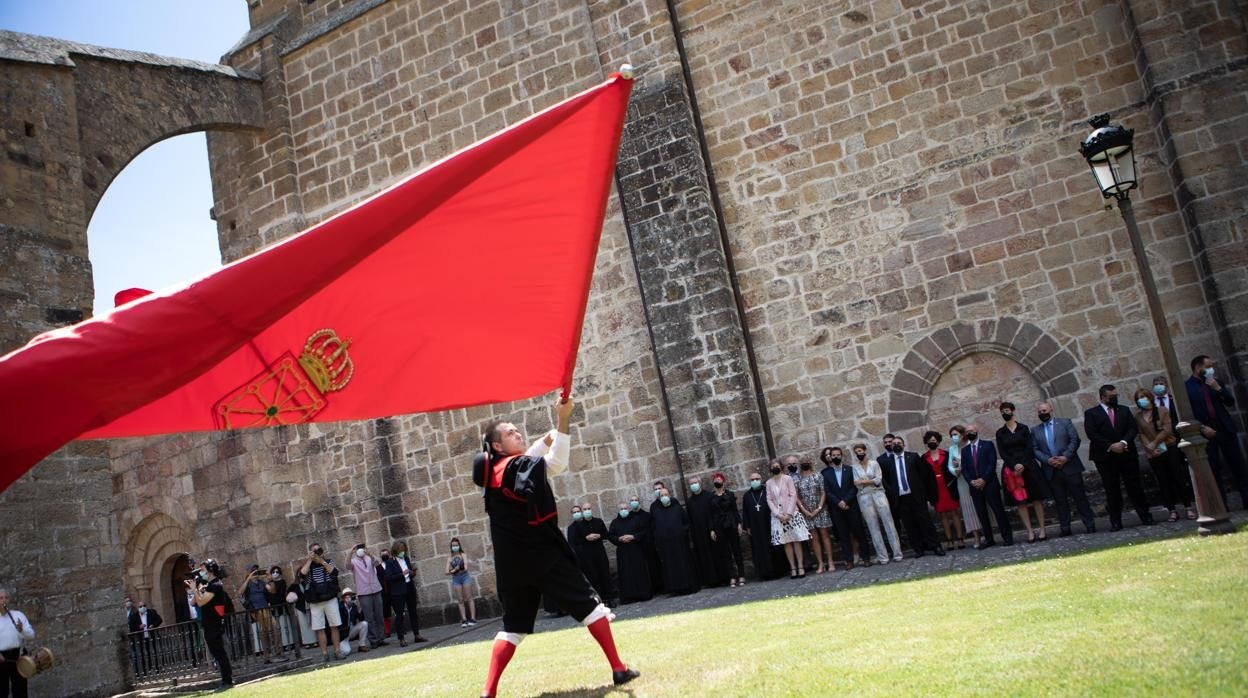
1080,114 -> 1234,536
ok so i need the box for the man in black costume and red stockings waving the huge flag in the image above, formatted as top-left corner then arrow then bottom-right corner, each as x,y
472,398 -> 639,697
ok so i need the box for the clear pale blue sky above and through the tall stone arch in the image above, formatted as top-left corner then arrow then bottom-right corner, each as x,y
0,0 -> 248,313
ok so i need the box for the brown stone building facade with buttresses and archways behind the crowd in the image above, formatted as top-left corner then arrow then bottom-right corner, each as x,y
0,0 -> 1248,693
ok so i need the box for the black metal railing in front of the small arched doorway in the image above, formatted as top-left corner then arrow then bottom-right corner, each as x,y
125,604 -> 303,686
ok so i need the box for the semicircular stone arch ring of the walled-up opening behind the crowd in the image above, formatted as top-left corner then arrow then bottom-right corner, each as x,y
889,317 -> 1080,432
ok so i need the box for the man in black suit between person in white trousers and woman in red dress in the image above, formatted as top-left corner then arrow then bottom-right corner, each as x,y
876,433 -> 945,557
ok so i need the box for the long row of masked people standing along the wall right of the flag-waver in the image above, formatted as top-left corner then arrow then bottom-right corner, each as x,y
567,355 -> 1248,603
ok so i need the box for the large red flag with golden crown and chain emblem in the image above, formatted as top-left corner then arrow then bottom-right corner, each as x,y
0,74 -> 631,488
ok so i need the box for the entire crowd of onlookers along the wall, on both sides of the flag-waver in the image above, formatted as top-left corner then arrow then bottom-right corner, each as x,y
114,356 -> 1248,686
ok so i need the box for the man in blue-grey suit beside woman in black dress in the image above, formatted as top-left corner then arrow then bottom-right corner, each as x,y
1031,402 -> 1096,536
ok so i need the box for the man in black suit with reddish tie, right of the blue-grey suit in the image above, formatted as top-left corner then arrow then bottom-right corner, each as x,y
1083,386 -> 1153,531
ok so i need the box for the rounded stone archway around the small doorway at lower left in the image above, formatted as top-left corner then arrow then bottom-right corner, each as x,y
125,512 -> 192,619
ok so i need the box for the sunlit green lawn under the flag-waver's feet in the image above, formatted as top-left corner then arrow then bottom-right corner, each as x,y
207,532 -> 1248,698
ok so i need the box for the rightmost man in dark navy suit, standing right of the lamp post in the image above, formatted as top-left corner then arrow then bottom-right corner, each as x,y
1183,353 -> 1248,509
